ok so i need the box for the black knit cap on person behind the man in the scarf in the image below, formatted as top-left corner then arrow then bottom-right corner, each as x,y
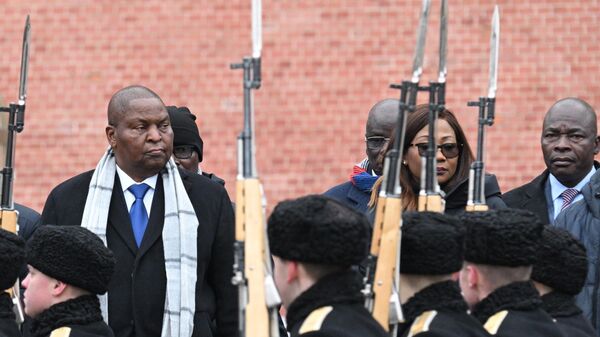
167,106 -> 204,162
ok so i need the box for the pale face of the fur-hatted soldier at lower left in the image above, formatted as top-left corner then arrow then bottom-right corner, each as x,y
21,266 -> 56,317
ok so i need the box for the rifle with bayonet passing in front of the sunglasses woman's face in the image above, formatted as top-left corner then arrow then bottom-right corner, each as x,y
419,0 -> 448,213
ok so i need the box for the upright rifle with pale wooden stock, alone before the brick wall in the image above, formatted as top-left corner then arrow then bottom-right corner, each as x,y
231,0 -> 281,337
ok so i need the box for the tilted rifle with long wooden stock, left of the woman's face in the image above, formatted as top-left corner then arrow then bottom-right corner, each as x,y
363,0 -> 430,336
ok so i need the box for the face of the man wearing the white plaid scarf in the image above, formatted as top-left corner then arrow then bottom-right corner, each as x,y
106,98 -> 173,181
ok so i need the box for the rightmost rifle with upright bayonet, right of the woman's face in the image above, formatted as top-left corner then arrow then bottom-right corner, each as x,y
466,5 -> 500,212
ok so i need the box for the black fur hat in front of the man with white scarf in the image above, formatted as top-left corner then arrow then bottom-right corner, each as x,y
27,225 -> 115,294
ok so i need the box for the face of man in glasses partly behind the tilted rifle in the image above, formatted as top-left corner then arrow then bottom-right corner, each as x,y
365,116 -> 396,175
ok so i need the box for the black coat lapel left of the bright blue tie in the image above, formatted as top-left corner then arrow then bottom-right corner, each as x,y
108,174 -> 138,255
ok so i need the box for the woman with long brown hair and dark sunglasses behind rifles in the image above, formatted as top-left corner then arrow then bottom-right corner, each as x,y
370,104 -> 506,214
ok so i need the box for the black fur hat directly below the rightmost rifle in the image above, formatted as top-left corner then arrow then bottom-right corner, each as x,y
460,208 -> 544,267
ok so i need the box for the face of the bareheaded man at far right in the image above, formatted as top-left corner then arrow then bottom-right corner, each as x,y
542,104 -> 598,187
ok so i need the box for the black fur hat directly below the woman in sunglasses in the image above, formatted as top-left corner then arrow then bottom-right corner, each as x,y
400,212 -> 464,275
